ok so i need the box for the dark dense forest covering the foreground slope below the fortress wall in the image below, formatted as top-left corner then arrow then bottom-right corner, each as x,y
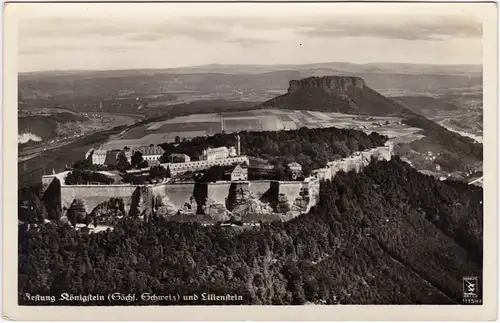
18,157 -> 483,305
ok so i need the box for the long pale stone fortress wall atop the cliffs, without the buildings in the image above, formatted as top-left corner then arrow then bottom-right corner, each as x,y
42,144 -> 393,220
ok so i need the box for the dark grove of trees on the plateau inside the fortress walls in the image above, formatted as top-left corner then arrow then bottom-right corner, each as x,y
161,127 -> 387,174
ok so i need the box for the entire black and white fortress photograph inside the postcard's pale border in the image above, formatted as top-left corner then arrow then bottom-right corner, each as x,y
4,3 -> 497,319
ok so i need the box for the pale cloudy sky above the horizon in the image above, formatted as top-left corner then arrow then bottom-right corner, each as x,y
16,3 -> 482,72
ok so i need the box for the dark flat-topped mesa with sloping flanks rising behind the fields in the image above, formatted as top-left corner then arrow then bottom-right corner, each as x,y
259,76 -> 415,117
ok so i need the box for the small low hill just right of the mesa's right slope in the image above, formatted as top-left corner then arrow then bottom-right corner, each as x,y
391,96 -> 461,117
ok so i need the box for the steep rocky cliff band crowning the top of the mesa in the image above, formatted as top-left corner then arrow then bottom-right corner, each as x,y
288,76 -> 365,93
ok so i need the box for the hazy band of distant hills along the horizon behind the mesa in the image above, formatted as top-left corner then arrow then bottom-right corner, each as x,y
19,62 -> 482,108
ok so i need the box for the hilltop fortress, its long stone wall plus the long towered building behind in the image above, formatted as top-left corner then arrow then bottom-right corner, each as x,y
42,141 -> 393,227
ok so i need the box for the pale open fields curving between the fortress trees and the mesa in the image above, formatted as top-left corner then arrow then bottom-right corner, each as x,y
102,109 -> 420,149
